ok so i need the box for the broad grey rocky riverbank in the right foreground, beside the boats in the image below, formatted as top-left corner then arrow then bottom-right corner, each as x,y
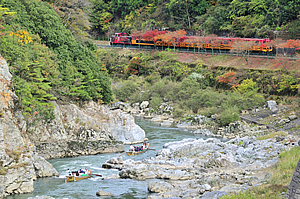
103,135 -> 298,198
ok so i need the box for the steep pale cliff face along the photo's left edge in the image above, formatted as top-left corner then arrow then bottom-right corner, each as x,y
0,56 -> 58,198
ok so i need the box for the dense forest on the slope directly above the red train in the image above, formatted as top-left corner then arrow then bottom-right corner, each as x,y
87,0 -> 300,38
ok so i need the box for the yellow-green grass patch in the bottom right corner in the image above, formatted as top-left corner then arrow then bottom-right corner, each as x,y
222,146 -> 300,199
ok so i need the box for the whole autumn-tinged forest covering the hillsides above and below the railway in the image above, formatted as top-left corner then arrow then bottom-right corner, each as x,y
0,0 -> 300,124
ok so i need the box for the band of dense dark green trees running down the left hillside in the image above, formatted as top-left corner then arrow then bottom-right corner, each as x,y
5,0 -> 112,103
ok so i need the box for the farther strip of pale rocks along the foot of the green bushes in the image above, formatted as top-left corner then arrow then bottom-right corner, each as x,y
109,100 -> 300,139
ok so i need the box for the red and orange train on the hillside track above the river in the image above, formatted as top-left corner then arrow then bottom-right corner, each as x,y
110,32 -> 274,53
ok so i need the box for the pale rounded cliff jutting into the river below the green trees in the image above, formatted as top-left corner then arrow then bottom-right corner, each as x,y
22,102 -> 145,159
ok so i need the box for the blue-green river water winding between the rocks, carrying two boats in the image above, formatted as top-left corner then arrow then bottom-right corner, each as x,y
7,118 -> 209,199
